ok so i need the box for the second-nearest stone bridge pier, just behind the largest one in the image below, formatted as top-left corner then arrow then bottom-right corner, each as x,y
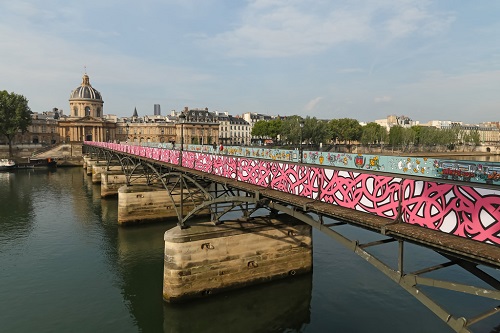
118,185 -> 210,225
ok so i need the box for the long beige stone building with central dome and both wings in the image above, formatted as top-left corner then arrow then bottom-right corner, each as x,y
13,73 -> 219,145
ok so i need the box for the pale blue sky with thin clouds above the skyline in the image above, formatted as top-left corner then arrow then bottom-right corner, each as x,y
0,0 -> 500,123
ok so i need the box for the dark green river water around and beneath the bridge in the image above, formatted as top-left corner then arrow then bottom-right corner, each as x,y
0,168 -> 500,333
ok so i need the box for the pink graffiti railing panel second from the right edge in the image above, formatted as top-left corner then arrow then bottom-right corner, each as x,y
320,169 -> 401,219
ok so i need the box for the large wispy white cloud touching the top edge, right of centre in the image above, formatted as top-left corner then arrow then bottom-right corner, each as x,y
203,0 -> 453,58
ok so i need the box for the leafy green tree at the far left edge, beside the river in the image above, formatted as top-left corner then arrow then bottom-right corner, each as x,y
0,90 -> 31,157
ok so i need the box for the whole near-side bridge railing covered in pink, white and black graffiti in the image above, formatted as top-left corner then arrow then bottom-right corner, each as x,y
86,142 -> 500,245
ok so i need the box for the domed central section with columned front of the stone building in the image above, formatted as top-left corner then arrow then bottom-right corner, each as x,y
59,73 -> 116,142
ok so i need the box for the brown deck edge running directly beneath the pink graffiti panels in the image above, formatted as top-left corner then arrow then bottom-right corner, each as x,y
182,166 -> 500,268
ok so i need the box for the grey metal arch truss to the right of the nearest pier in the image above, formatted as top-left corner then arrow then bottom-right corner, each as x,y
265,200 -> 500,333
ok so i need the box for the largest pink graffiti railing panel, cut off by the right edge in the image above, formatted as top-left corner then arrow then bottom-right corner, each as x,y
402,180 -> 500,244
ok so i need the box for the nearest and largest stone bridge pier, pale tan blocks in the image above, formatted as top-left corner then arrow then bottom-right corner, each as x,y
163,216 -> 312,302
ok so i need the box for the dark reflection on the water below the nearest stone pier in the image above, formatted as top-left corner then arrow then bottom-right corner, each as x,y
163,274 -> 312,333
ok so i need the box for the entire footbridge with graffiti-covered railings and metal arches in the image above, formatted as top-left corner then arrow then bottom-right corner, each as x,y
84,142 -> 500,332
